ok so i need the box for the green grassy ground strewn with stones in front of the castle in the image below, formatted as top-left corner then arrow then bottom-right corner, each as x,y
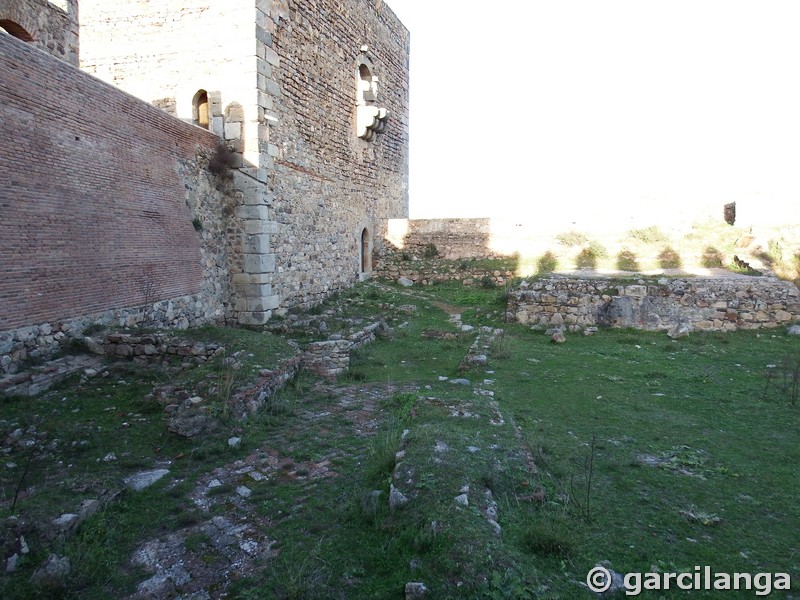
0,283 -> 800,598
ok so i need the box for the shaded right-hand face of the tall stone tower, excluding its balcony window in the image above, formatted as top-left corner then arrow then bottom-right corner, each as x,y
266,0 -> 409,310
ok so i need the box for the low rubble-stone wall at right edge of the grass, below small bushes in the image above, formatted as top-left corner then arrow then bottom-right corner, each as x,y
508,277 -> 800,331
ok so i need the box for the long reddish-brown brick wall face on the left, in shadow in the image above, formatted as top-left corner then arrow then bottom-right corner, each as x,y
0,35 -> 216,331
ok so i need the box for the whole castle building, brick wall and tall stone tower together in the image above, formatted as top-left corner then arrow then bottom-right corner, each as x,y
0,0 -> 409,372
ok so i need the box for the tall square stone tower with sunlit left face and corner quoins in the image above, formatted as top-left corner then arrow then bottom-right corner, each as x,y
81,0 -> 409,325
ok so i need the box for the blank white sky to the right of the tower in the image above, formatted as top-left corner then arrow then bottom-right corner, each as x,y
387,0 -> 800,220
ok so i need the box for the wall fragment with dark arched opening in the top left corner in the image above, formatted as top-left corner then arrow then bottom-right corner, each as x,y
0,0 -> 78,66
